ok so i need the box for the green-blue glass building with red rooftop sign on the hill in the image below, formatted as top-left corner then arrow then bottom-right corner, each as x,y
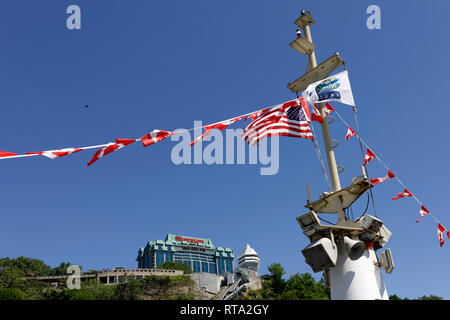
136,233 -> 234,276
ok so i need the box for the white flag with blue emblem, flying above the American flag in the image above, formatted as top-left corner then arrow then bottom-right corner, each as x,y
302,71 -> 355,106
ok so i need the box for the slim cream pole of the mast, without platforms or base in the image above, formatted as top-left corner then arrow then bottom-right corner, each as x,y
302,25 -> 341,191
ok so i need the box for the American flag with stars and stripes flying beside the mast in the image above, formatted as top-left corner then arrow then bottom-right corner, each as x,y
242,99 -> 313,145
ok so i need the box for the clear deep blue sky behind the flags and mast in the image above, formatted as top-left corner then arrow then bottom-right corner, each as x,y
0,0 -> 450,299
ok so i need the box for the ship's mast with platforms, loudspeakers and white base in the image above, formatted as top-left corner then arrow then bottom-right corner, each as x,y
288,11 -> 393,300
